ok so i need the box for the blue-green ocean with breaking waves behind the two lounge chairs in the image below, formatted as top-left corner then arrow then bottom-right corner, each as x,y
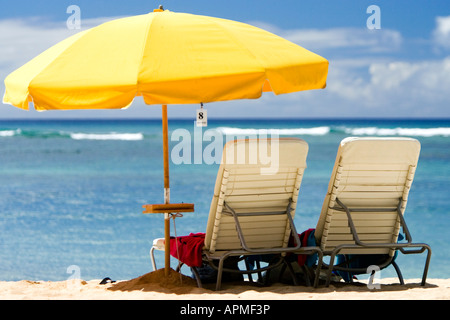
0,119 -> 450,281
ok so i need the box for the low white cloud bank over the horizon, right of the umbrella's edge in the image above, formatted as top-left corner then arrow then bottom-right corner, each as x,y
327,57 -> 450,116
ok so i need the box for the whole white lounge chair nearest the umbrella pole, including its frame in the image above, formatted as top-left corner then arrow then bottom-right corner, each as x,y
150,138 -> 321,290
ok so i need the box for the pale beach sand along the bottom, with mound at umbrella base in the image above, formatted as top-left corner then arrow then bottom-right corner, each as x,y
0,269 -> 450,301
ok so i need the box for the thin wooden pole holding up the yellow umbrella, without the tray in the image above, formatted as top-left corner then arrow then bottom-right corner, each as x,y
162,105 -> 170,277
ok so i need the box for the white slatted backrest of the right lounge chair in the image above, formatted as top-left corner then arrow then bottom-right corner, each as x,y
315,137 -> 420,255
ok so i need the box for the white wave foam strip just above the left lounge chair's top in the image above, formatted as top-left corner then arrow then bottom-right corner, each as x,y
217,126 -> 330,136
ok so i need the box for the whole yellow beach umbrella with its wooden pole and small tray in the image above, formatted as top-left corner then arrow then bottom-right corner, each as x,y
3,9 -> 328,274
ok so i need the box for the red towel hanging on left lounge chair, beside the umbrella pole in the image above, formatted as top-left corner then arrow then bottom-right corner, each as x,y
170,233 -> 205,267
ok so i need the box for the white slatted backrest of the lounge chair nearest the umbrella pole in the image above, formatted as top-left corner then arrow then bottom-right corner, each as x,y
205,138 -> 308,253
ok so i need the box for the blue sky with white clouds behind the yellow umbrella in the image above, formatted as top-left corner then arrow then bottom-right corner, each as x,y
0,0 -> 450,120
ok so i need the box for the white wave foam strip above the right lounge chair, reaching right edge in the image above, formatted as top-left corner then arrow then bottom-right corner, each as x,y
345,127 -> 450,137
